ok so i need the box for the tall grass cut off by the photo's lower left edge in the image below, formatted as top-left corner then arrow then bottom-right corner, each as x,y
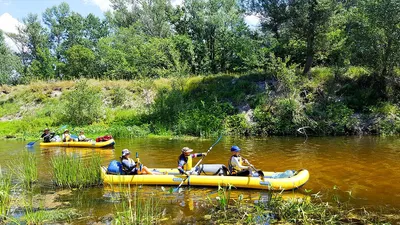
0,167 -> 11,219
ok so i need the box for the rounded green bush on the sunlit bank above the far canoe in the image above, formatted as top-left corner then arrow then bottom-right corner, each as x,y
60,80 -> 103,125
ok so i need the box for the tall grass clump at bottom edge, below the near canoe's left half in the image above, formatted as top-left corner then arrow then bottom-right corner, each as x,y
114,185 -> 162,225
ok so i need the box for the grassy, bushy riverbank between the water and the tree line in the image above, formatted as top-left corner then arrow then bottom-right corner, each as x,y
0,67 -> 400,139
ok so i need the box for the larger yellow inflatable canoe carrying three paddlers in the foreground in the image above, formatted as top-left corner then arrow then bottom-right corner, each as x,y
101,167 -> 310,191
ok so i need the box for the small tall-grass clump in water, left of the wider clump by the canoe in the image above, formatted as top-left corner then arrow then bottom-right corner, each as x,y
10,152 -> 38,188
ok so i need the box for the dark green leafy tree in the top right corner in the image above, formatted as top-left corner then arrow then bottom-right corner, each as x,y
347,0 -> 400,79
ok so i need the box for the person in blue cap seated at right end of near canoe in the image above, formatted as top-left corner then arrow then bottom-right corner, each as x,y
228,145 -> 251,176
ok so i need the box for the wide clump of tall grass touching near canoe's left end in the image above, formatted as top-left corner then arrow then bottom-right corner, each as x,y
51,154 -> 102,188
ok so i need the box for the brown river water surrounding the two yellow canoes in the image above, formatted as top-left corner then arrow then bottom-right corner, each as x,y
0,137 -> 400,224
